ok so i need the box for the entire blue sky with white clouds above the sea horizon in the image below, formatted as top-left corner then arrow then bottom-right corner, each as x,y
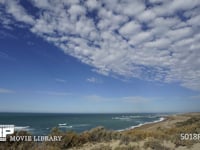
0,0 -> 200,113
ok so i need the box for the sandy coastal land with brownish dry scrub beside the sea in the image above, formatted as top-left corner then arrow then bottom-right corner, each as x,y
0,112 -> 200,150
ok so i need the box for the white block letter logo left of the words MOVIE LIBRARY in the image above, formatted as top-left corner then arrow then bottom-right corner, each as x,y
0,125 -> 14,141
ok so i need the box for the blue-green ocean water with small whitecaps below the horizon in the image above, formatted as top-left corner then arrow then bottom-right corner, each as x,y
0,113 -> 168,135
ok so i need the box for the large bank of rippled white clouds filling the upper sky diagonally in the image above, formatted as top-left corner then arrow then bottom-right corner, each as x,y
0,0 -> 200,90
